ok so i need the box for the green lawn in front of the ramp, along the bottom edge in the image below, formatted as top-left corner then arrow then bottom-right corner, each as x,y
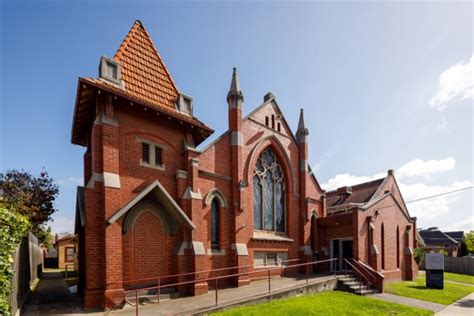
213,291 -> 433,316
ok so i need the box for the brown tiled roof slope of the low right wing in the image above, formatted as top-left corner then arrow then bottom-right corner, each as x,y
326,178 -> 385,207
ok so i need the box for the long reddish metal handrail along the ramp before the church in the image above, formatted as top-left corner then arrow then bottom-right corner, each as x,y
124,258 -> 339,315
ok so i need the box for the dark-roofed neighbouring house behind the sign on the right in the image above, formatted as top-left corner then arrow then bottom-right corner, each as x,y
419,227 -> 464,257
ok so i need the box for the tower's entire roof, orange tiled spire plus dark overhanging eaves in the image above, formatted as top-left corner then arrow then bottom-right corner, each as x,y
71,21 -> 214,146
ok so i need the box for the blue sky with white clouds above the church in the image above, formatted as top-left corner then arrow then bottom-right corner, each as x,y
0,1 -> 474,232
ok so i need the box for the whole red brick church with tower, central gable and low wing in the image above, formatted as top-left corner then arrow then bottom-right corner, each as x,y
72,21 -> 417,307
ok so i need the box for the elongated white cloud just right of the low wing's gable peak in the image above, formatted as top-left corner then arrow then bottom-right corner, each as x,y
396,157 -> 456,179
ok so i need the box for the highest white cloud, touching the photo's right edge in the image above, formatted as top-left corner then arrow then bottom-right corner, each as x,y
428,55 -> 474,111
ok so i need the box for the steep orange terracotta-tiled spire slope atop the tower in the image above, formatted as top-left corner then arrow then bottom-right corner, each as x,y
114,20 -> 179,109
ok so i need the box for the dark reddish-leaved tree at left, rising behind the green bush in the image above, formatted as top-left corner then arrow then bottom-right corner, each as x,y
0,169 -> 59,246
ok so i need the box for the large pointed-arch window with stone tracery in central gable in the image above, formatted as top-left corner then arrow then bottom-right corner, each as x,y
253,148 -> 285,232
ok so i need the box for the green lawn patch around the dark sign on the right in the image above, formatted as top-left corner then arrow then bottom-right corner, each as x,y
385,276 -> 474,305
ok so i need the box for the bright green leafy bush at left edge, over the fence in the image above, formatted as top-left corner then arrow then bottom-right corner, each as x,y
0,201 -> 31,315
